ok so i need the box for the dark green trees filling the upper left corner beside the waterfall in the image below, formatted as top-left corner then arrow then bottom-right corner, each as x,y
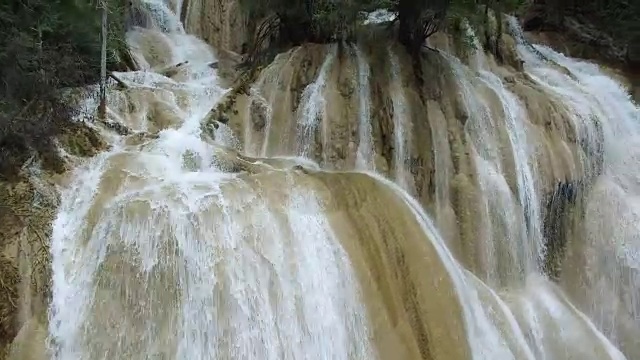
0,0 -> 124,179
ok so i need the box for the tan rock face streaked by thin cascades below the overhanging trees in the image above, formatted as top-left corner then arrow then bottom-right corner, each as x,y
215,30 -> 590,282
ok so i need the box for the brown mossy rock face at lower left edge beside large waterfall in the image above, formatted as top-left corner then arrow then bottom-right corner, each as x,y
0,178 -> 57,358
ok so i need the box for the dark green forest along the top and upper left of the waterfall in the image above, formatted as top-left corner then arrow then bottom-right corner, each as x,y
0,0 -> 640,179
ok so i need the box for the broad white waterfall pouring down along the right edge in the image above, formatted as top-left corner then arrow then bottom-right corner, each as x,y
509,18 -> 640,358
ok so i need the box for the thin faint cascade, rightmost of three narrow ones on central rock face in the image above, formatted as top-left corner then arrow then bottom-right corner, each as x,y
388,48 -> 412,193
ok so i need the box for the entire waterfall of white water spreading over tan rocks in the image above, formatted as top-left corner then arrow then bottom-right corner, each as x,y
30,0 -> 640,360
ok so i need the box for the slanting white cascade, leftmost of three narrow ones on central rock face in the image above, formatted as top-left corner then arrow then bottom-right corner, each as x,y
296,44 -> 338,158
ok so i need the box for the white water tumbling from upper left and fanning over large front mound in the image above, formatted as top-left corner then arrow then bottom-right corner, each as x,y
49,2 -> 374,360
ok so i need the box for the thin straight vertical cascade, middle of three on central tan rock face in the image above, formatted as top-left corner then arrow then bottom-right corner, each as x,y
353,45 -> 376,171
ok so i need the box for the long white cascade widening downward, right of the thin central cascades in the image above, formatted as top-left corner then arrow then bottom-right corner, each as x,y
445,55 -> 537,286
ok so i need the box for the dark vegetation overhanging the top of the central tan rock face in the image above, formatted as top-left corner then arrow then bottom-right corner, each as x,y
240,0 -> 523,69
